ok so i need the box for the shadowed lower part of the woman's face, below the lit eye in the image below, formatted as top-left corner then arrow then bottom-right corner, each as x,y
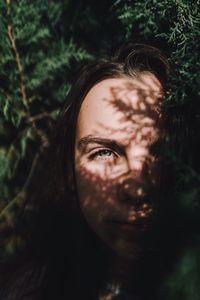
77,159 -> 158,257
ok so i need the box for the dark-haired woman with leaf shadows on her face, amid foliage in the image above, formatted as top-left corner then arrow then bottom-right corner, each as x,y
1,43 -> 169,300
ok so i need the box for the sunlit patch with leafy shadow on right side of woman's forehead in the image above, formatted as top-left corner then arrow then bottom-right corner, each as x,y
99,75 -> 163,137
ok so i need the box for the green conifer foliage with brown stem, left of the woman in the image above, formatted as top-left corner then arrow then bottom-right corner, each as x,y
0,0 -> 122,208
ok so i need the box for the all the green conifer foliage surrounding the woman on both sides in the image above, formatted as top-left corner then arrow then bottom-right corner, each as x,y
0,0 -> 200,299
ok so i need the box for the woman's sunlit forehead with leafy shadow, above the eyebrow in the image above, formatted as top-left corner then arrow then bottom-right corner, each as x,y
77,72 -> 162,141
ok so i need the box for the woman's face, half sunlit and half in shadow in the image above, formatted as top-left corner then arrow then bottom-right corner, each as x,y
75,72 -> 162,258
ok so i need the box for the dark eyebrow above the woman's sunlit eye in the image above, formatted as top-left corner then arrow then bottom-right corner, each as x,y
78,135 -> 125,153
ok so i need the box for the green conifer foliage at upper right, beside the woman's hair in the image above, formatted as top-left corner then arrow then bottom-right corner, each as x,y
115,0 -> 200,104
